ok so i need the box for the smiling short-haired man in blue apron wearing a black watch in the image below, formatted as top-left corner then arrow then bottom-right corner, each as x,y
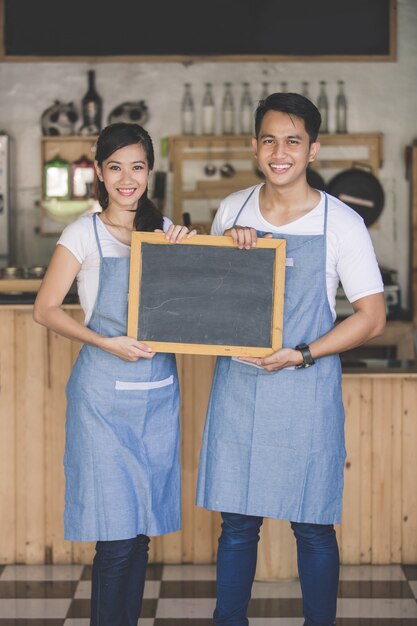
197,93 -> 385,626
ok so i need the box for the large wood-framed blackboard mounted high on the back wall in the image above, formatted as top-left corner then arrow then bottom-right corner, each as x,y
0,0 -> 397,60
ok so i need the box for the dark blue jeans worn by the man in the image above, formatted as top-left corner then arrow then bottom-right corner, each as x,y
213,513 -> 339,626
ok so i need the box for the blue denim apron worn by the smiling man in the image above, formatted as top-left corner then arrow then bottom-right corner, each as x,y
197,190 -> 346,524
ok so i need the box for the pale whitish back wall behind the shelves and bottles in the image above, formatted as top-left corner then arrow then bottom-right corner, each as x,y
0,0 -> 417,308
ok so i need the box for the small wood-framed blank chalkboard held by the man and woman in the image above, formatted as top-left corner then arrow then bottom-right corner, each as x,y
127,232 -> 286,356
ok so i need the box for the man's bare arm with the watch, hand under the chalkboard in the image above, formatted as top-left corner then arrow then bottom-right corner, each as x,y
241,293 -> 386,372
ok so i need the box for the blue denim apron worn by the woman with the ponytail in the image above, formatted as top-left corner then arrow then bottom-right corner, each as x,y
64,216 -> 181,541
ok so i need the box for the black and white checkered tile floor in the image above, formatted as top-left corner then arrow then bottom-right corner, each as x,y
0,565 -> 417,626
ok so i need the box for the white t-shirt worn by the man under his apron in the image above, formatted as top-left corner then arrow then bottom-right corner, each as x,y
211,183 -> 384,319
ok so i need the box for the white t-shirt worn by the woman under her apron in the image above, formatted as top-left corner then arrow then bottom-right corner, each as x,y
56,215 -> 172,324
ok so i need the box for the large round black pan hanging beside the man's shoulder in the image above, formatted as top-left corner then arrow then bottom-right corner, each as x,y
326,164 -> 385,227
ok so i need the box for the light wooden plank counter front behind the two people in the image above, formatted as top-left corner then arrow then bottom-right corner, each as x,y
0,305 -> 417,579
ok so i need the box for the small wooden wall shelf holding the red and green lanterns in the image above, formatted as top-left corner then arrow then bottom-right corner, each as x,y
40,135 -> 97,235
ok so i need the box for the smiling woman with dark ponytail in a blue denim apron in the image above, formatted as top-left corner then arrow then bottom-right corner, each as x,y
33,123 -> 195,626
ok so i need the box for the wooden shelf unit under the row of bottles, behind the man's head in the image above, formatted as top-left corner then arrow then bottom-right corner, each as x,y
169,133 -> 383,227
